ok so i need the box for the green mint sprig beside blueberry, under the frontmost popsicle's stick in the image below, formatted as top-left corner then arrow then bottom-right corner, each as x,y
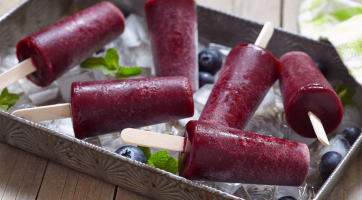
138,146 -> 178,174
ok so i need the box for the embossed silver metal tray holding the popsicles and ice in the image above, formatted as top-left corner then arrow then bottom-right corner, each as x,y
0,0 -> 362,200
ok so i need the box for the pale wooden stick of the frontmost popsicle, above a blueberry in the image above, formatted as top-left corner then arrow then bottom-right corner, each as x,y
121,128 -> 187,152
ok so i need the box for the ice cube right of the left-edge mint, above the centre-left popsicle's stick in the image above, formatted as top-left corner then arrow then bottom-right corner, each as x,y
18,78 -> 59,104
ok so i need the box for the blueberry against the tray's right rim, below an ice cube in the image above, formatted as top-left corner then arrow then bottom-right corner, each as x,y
319,151 -> 342,181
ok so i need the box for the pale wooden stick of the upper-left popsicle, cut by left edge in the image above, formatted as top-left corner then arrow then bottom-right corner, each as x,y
0,58 -> 37,90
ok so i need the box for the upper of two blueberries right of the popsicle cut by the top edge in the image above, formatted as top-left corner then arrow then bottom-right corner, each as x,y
199,49 -> 222,75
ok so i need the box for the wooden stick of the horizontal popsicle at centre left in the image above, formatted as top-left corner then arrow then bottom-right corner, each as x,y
12,103 -> 72,122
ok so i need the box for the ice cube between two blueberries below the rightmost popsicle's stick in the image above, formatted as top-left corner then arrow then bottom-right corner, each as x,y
318,135 -> 351,160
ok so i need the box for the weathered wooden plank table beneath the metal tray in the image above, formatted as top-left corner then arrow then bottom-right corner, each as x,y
0,0 -> 362,200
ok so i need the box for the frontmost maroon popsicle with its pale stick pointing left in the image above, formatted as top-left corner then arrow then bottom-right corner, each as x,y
121,121 -> 309,186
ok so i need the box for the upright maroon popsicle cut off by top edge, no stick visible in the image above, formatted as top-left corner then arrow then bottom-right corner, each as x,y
144,0 -> 199,92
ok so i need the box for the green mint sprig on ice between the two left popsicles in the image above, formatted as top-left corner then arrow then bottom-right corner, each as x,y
80,48 -> 142,78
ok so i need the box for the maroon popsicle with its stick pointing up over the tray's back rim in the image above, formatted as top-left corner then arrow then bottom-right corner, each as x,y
199,23 -> 280,129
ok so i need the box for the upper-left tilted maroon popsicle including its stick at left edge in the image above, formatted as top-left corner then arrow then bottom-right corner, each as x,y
0,2 -> 125,90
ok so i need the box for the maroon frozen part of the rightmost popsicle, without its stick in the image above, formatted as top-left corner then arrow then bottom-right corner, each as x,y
280,51 -> 343,138
